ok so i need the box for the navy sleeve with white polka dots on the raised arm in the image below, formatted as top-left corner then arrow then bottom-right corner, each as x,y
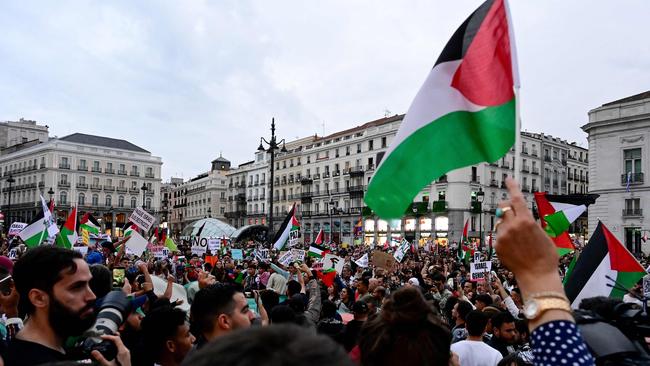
530,320 -> 595,366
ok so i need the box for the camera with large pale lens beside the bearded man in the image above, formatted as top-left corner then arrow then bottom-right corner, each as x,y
69,290 -> 131,360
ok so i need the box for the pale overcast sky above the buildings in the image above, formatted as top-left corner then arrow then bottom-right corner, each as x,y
0,0 -> 650,180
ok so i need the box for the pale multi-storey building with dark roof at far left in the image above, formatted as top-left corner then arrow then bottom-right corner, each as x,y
0,133 -> 162,236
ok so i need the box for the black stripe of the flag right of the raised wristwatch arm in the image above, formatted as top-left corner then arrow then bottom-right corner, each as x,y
564,222 -> 609,303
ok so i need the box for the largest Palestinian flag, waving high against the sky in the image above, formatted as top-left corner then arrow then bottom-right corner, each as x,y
365,0 -> 516,218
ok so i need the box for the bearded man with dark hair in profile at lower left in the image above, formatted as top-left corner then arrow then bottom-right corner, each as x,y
4,246 -> 95,366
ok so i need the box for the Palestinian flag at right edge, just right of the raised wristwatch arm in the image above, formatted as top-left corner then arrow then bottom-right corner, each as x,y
564,222 -> 646,308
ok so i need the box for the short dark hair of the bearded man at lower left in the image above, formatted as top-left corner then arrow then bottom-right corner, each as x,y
13,245 -> 83,317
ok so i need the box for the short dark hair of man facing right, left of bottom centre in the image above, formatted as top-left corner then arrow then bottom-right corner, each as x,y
190,283 -> 241,336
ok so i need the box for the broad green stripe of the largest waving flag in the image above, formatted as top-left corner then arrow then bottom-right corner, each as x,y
365,98 -> 515,218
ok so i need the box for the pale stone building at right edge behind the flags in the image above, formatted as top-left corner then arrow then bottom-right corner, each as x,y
582,91 -> 650,254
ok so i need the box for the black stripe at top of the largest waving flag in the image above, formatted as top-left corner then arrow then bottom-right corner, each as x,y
434,0 -> 494,67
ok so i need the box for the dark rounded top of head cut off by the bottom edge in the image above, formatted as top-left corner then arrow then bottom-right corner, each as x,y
183,324 -> 352,366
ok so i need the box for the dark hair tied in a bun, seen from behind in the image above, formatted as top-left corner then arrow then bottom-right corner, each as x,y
359,287 -> 451,366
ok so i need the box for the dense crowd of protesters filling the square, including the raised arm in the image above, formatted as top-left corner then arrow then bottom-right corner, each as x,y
0,180 -> 636,366
